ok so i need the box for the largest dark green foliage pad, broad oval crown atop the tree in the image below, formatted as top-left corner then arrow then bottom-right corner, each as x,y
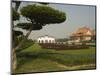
21,5 -> 66,25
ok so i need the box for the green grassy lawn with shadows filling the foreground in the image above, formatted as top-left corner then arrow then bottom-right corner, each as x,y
15,44 -> 96,73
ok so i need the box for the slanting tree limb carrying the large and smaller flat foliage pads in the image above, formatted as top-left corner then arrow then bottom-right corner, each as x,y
11,4 -> 66,72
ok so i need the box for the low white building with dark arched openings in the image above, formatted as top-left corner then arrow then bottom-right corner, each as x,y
37,35 -> 55,43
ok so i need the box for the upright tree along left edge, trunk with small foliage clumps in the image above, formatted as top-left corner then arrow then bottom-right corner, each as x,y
12,1 -> 23,71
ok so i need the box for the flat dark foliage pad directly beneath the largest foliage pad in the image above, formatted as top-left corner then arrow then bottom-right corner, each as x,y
17,23 -> 42,30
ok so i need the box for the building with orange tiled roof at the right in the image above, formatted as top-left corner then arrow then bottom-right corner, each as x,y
70,27 -> 95,42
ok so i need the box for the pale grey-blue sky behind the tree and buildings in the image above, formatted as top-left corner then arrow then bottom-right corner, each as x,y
13,2 -> 96,40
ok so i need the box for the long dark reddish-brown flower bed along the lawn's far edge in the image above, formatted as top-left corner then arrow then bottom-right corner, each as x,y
40,43 -> 89,50
